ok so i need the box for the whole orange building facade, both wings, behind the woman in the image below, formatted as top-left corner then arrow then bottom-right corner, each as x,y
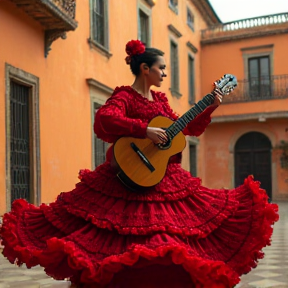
0,0 -> 288,215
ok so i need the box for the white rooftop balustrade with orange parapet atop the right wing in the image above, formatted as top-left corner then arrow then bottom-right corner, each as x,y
201,13 -> 288,45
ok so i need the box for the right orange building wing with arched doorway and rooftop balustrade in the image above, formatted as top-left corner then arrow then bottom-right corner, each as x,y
201,13 -> 288,200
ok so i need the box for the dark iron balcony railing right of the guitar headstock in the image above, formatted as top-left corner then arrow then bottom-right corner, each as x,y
223,75 -> 288,103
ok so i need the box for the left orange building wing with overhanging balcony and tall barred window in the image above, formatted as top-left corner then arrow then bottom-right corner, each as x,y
0,0 -> 220,215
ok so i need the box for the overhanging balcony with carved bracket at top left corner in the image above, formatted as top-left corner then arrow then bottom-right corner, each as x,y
10,0 -> 77,57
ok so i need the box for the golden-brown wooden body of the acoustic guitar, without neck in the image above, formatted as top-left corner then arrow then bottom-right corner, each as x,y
114,116 -> 186,190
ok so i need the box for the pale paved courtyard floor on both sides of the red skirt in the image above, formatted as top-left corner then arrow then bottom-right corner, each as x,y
0,202 -> 288,288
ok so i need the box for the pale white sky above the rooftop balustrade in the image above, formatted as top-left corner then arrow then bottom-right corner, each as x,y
209,0 -> 288,23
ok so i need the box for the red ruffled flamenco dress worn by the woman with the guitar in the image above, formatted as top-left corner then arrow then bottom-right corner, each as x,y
1,86 -> 278,288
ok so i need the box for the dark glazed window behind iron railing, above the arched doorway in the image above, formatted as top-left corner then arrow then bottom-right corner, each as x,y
248,56 -> 271,100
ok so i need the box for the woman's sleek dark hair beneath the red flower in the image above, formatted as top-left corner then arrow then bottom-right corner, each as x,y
130,48 -> 164,76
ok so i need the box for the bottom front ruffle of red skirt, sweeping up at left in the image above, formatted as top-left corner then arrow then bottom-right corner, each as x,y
2,200 -> 237,287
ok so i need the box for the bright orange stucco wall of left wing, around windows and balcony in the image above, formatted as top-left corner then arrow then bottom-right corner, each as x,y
0,0 -> 212,215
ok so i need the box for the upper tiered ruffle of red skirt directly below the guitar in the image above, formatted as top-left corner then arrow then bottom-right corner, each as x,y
56,164 -> 238,238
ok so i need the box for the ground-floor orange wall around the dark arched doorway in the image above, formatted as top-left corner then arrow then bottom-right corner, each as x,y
202,119 -> 288,199
